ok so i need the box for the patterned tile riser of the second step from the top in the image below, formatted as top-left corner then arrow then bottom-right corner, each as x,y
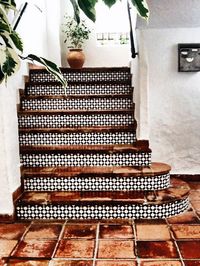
26,83 -> 133,96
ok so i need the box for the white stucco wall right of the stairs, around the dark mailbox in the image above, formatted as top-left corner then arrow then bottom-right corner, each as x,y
136,0 -> 200,174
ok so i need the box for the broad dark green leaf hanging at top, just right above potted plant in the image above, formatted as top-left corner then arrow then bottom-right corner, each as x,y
78,0 -> 97,22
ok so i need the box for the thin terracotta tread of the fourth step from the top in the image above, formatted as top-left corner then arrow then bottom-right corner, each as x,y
18,109 -> 134,115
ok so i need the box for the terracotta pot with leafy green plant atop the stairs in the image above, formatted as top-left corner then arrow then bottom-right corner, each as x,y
63,16 -> 90,69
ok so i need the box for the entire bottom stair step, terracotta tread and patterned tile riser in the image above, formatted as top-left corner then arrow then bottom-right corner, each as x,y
16,179 -> 189,220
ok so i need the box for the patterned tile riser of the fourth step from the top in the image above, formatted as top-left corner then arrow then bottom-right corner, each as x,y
18,114 -> 134,128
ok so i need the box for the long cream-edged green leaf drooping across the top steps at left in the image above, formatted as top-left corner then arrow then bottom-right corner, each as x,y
24,54 -> 67,88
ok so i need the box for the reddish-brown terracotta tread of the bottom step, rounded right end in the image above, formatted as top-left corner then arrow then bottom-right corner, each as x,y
18,179 -> 190,205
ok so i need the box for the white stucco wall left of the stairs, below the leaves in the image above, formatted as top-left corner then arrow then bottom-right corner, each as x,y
0,78 -> 20,214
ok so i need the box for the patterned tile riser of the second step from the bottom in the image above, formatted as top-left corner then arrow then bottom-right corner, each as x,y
23,174 -> 170,191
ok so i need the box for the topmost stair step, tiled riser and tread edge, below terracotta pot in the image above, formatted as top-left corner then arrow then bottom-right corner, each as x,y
29,67 -> 131,83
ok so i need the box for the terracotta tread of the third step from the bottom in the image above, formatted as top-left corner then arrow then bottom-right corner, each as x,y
20,140 -> 151,152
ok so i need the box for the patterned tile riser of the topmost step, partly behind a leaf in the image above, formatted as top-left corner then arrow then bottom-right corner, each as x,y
30,70 -> 131,83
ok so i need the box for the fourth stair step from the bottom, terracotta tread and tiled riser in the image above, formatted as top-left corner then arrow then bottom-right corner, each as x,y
19,127 -> 136,146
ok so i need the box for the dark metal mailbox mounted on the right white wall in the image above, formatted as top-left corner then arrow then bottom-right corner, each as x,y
178,43 -> 200,72
